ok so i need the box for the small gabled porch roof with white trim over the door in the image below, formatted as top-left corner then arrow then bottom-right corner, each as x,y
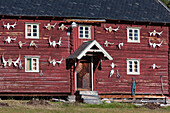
67,40 -> 113,60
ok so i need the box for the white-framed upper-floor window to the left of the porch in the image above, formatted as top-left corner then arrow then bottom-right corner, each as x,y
25,23 -> 39,39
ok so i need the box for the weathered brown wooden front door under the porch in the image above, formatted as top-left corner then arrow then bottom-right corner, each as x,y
76,60 -> 92,91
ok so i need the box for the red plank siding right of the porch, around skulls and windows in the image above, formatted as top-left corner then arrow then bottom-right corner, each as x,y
95,23 -> 169,94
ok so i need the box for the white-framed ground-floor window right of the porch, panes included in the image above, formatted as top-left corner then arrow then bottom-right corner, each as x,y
127,59 -> 140,75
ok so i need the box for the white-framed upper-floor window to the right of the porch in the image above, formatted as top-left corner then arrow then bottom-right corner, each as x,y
127,28 -> 140,43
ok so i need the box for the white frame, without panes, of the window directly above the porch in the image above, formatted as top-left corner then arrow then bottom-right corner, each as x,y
78,25 -> 91,39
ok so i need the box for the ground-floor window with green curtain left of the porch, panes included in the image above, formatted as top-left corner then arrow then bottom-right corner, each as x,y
25,56 -> 39,72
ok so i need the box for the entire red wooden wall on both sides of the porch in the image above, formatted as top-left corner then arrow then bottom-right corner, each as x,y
0,19 -> 169,94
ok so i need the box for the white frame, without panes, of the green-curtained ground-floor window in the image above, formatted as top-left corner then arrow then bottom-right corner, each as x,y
25,56 -> 40,72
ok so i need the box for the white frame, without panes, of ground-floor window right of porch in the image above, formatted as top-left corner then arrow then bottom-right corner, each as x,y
126,59 -> 140,75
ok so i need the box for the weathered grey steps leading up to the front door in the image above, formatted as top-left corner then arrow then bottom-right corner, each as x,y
76,91 -> 102,104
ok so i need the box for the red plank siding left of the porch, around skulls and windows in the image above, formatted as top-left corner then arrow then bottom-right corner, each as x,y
0,19 -> 70,94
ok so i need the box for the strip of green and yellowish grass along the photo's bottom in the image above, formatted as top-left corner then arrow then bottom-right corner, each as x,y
0,100 -> 170,113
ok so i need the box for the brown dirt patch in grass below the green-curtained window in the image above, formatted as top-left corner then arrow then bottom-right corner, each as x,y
27,100 -> 51,106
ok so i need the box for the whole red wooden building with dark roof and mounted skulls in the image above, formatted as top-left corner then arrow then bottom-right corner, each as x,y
0,0 -> 170,99
